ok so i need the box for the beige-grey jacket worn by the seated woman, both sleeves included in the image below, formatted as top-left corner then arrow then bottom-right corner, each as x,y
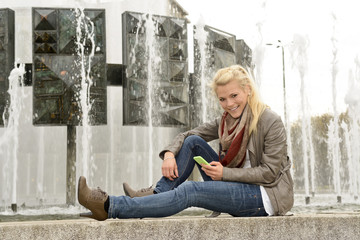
160,109 -> 294,215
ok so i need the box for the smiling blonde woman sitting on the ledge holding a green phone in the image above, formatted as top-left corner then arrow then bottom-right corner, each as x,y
78,65 -> 294,220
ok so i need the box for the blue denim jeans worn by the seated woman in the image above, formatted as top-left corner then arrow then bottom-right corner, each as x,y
108,136 -> 267,218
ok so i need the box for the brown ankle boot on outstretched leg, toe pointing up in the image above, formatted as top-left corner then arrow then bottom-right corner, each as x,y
78,176 -> 108,221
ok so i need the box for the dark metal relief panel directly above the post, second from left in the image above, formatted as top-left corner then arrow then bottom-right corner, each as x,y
33,8 -> 107,125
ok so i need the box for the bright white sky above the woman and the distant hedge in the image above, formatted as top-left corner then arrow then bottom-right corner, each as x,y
178,0 -> 360,121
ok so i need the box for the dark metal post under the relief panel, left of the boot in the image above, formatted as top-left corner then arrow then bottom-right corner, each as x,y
66,125 -> 76,205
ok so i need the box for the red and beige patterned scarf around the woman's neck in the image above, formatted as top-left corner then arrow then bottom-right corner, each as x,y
218,104 -> 252,168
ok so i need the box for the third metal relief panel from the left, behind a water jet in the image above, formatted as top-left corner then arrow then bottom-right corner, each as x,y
122,12 -> 189,126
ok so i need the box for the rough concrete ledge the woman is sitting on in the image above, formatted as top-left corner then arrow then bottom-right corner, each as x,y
0,213 -> 360,240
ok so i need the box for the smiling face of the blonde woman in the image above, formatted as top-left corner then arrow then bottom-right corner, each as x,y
216,80 -> 250,118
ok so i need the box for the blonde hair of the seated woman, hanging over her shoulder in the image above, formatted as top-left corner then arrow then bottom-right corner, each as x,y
211,65 -> 267,134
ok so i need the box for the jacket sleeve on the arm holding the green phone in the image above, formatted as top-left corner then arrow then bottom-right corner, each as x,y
223,115 -> 287,186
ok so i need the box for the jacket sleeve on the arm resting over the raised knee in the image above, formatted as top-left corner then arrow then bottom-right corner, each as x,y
159,118 -> 220,159
